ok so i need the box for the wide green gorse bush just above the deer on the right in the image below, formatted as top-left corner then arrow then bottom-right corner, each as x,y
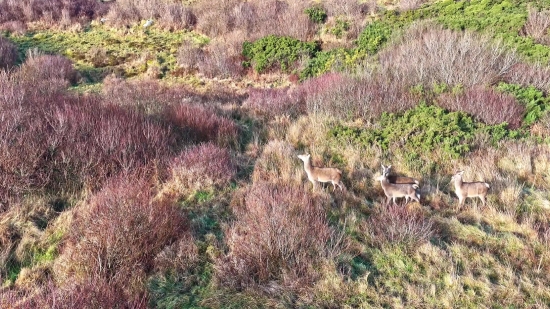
329,104 -> 509,159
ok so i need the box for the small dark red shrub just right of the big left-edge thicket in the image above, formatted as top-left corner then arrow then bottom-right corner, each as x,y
165,103 -> 239,146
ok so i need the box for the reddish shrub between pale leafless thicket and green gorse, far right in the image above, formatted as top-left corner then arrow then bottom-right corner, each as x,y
437,87 -> 525,129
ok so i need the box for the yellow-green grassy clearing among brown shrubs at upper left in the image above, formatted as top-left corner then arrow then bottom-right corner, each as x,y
4,25 -> 208,80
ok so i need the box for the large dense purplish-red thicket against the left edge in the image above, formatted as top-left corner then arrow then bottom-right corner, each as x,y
0,67 -> 172,207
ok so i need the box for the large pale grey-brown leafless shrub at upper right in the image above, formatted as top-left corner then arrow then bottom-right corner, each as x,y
380,23 -> 517,87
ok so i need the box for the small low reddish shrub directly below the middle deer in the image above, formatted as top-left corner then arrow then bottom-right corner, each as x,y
361,205 -> 434,251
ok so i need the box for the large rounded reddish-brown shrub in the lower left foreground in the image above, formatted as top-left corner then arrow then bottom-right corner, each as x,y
62,175 -> 187,295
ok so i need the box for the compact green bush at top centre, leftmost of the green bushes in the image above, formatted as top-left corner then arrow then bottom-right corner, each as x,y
243,35 -> 319,73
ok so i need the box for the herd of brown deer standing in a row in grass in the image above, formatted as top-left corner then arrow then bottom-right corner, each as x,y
298,154 -> 490,207
